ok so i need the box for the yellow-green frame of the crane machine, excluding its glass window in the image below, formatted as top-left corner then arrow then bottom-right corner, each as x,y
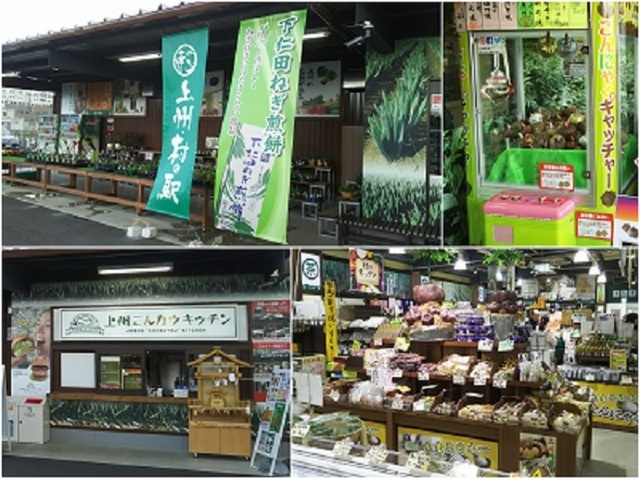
455,2 -> 638,246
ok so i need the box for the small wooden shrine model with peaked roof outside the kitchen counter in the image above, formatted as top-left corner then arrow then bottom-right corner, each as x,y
188,348 -> 252,458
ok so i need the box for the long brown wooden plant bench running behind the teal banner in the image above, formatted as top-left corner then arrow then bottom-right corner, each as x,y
2,158 -> 213,230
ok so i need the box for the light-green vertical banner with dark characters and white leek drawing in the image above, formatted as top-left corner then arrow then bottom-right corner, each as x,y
214,10 -> 307,244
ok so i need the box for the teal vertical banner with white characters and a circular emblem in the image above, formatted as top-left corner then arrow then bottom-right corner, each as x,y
147,28 -> 209,219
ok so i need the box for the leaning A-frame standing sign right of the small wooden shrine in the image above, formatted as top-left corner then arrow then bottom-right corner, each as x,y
251,369 -> 291,475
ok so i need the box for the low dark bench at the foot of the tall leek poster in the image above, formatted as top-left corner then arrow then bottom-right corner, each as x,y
338,215 -> 441,246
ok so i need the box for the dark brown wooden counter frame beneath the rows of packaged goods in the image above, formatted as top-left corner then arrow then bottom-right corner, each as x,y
315,403 -> 591,477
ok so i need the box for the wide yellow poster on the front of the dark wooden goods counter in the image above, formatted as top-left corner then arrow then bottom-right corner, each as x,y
398,426 -> 498,469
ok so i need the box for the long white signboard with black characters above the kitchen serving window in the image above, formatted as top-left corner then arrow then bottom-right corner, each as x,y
53,304 -> 247,341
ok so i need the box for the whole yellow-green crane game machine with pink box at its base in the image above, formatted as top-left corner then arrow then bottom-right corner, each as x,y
455,2 -> 638,246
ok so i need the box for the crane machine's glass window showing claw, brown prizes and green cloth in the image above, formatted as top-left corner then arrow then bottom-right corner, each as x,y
473,30 -> 591,194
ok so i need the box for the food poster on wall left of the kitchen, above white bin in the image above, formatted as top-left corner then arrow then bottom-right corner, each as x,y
10,306 -> 51,396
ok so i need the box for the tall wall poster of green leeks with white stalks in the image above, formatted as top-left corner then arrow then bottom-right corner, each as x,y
362,38 -> 441,230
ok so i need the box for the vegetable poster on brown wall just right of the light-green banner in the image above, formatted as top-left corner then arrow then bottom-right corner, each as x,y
296,61 -> 342,116
